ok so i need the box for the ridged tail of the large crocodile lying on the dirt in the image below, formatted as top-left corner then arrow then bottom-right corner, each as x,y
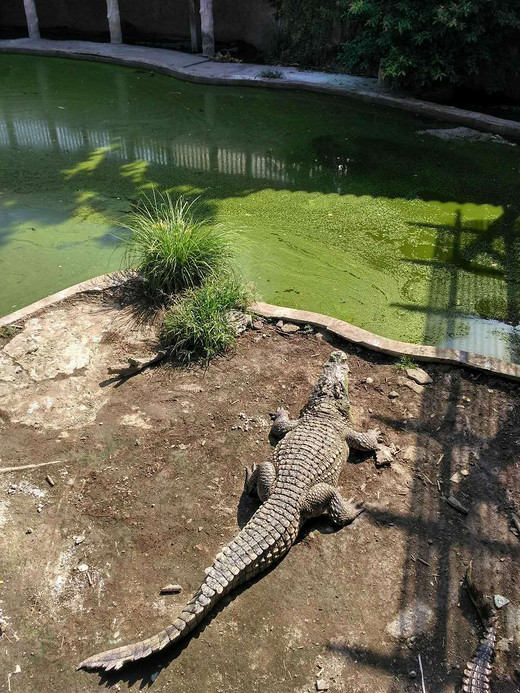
78,501 -> 298,671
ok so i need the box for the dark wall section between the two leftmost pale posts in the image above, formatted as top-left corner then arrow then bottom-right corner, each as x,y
35,0 -> 110,41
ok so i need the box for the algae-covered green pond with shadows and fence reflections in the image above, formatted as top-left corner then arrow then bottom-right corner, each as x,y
0,55 -> 520,360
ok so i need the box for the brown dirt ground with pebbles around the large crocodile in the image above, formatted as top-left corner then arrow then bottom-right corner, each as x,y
0,296 -> 520,693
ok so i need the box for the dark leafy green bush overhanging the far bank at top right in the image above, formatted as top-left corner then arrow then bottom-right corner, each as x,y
338,0 -> 520,91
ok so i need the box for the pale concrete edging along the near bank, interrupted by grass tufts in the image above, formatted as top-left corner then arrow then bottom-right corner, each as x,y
0,274 -> 520,381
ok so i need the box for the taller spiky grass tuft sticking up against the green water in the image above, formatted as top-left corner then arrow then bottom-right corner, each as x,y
123,194 -> 232,303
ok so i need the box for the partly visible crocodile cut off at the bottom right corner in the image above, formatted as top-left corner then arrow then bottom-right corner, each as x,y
462,563 -> 508,693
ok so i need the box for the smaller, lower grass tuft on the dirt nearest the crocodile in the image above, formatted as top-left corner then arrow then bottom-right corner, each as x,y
162,277 -> 251,362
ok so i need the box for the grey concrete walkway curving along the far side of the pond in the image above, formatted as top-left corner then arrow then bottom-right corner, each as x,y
0,39 -> 520,139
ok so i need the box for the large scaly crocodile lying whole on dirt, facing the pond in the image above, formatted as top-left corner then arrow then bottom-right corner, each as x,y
78,351 -> 391,670
